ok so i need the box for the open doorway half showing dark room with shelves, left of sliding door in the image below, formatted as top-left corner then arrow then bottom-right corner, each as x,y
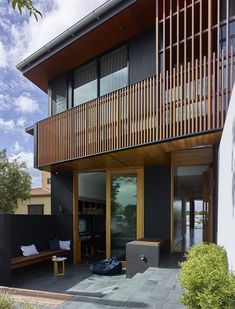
78,172 -> 106,263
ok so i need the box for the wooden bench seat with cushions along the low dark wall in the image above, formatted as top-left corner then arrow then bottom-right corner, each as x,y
11,250 -> 70,269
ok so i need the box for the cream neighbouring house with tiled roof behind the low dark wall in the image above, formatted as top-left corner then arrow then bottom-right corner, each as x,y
15,172 -> 51,215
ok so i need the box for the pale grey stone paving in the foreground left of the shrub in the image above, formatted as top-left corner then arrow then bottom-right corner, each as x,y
59,268 -> 184,309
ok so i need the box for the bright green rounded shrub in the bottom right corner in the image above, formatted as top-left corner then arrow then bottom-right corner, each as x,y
179,243 -> 235,309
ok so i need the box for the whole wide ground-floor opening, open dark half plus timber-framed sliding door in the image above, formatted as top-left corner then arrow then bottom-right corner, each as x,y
78,169 -> 144,263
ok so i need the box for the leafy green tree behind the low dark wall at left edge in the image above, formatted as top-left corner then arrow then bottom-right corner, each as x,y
0,149 -> 31,213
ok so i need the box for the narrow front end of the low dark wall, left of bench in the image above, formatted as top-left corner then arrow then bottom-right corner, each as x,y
0,215 -> 11,286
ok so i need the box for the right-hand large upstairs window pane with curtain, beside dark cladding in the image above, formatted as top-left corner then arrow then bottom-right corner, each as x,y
100,46 -> 128,95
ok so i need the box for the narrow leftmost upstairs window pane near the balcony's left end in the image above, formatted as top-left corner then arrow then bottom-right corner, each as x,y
51,76 -> 67,115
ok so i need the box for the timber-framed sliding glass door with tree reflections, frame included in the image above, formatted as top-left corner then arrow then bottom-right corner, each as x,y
106,169 -> 143,260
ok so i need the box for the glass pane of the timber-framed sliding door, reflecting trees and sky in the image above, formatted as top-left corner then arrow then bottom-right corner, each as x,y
111,174 -> 137,260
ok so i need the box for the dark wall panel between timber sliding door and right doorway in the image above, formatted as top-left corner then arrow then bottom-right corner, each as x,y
144,166 -> 171,239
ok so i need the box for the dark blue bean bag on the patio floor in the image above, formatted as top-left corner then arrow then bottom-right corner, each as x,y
90,257 -> 122,276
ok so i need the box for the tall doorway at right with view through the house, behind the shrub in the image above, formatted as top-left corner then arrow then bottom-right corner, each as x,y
172,165 -> 213,252
